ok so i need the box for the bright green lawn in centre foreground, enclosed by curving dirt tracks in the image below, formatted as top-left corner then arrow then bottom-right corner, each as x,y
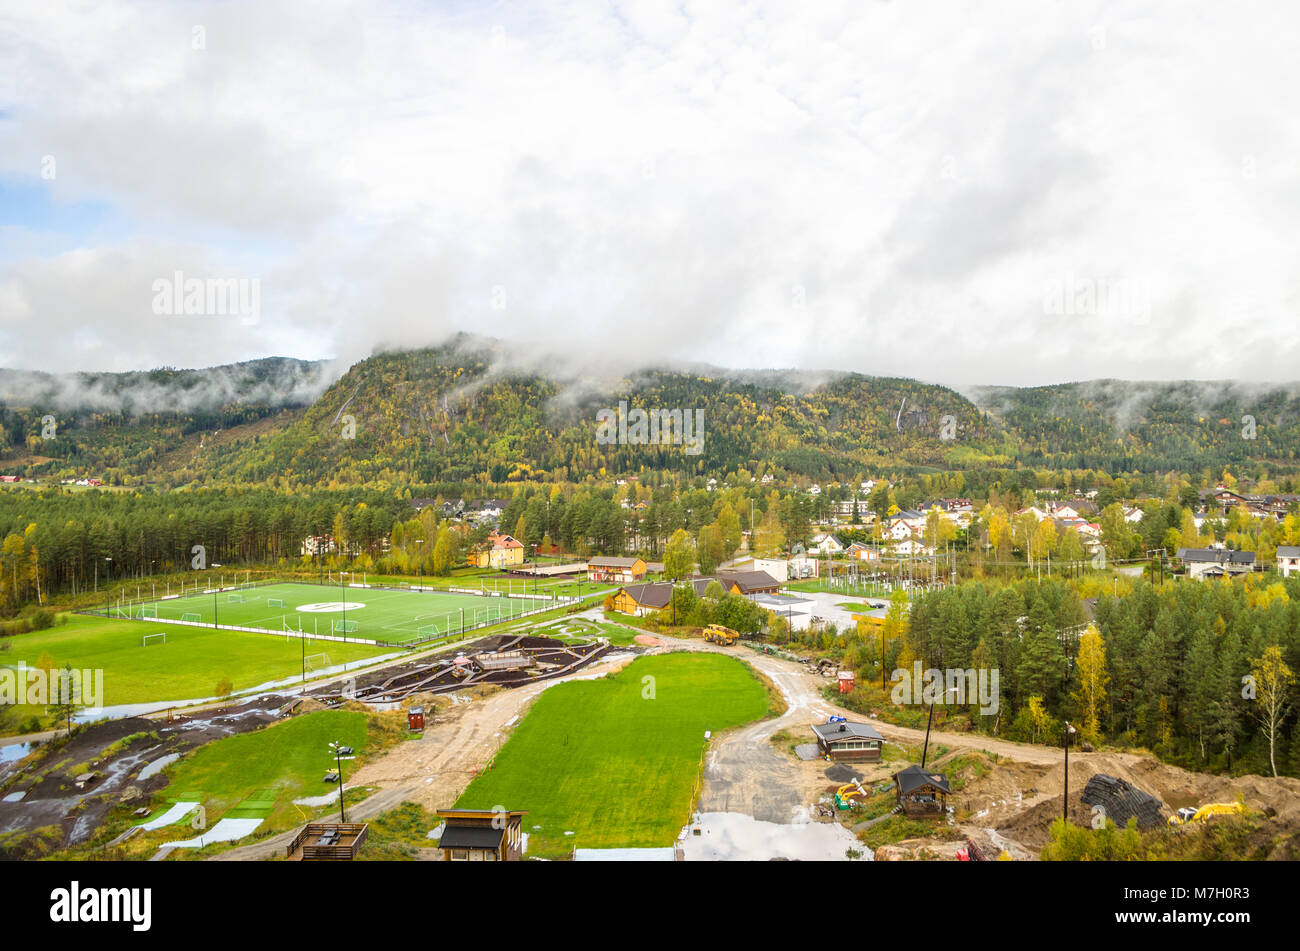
456,653 -> 768,857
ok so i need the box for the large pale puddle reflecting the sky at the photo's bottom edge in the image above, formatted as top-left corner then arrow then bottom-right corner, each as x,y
677,812 -> 875,861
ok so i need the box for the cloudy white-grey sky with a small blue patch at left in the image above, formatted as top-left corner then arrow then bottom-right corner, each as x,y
0,0 -> 1300,386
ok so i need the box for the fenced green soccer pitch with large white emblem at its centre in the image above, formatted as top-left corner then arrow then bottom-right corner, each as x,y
112,582 -> 556,644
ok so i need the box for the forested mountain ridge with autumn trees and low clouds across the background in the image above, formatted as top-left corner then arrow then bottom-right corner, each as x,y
0,335 -> 1300,487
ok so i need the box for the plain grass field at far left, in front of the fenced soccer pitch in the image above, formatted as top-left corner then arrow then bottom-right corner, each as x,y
0,615 -> 393,713
